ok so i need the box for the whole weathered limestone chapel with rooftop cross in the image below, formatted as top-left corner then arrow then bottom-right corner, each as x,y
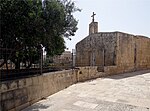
76,13 -> 150,73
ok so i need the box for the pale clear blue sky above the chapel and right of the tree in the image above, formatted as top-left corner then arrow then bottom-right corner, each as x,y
65,0 -> 150,50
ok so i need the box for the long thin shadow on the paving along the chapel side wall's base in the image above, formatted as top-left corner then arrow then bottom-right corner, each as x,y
106,70 -> 150,79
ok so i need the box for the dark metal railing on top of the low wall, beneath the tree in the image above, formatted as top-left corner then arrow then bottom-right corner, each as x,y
0,48 -> 75,81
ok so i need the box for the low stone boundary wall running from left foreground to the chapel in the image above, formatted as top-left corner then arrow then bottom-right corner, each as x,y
0,67 -> 105,111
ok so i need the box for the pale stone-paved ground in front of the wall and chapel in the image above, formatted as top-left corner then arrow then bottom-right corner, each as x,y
23,70 -> 150,111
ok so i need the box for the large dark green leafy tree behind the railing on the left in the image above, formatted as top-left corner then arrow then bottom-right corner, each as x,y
0,0 -> 80,69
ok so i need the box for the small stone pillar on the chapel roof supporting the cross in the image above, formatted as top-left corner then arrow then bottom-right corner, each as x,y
89,22 -> 98,35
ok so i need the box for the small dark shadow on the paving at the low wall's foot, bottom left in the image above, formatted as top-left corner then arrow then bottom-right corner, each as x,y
22,103 -> 49,111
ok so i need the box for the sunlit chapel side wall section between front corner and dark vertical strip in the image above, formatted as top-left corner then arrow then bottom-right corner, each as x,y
117,33 -> 136,72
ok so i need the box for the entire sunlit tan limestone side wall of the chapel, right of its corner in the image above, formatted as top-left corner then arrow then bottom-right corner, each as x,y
104,32 -> 150,75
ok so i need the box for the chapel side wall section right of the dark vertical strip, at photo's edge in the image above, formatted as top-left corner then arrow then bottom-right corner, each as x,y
135,36 -> 150,70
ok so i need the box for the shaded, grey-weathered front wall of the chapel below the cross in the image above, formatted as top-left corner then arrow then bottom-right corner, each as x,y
76,32 -> 117,66
